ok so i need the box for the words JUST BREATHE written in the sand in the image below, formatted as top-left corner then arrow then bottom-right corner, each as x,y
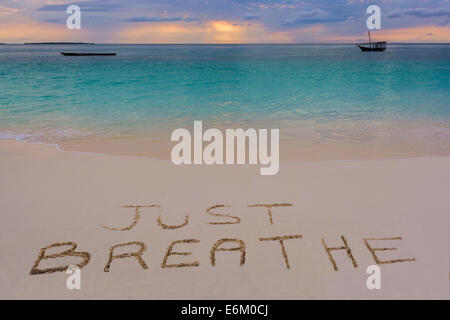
30,203 -> 415,275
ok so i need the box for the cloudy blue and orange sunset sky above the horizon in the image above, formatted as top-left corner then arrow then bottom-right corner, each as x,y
0,0 -> 450,43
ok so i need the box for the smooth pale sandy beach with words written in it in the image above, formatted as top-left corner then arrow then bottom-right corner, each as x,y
0,140 -> 450,299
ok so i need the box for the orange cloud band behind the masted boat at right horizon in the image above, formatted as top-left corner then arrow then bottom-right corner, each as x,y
320,26 -> 450,42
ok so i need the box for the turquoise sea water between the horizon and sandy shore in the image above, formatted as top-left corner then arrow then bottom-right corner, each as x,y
0,45 -> 450,155
